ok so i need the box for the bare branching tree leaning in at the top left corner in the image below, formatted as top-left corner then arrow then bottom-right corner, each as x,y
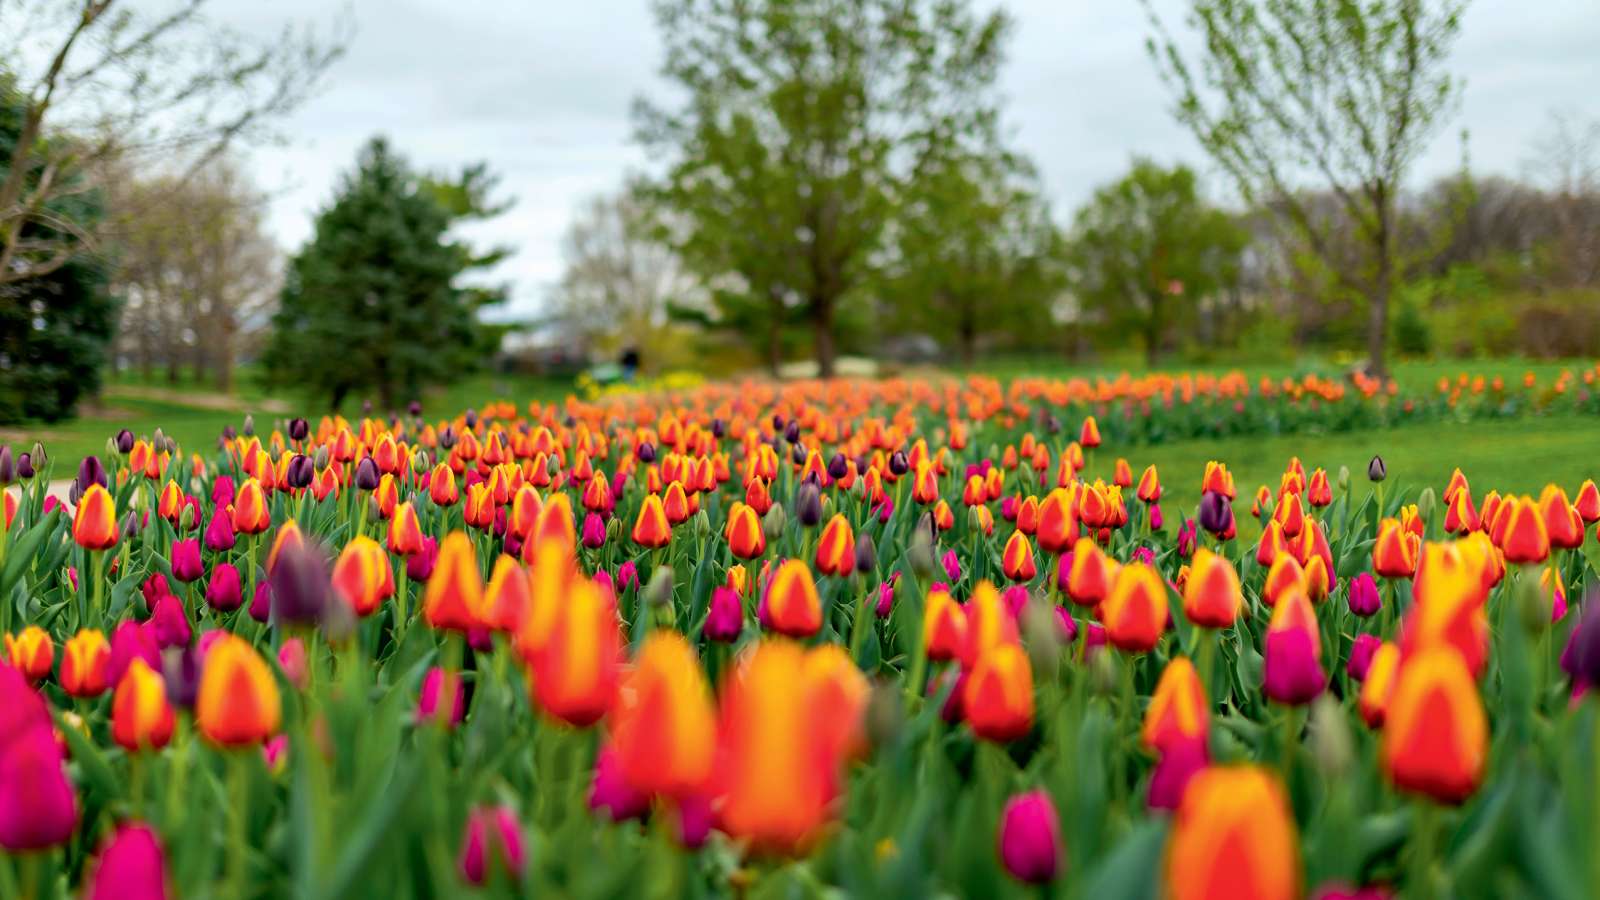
0,0 -> 342,285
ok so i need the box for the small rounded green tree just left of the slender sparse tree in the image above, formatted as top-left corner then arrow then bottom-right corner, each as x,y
1067,160 -> 1250,365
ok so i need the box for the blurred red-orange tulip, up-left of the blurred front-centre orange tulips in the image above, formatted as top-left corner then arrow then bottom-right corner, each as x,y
530,578 -> 622,727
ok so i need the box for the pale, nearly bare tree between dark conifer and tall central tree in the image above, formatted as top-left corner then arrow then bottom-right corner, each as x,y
552,191 -> 701,365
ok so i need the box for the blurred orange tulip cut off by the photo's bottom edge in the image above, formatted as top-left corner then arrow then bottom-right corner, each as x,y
1165,765 -> 1301,900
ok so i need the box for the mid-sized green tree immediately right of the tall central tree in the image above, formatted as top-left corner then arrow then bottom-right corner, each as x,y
891,152 -> 1061,364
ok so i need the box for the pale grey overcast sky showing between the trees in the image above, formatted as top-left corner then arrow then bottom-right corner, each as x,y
203,0 -> 1600,317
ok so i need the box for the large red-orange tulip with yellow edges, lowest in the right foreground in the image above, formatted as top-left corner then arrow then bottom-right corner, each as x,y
1379,645 -> 1488,804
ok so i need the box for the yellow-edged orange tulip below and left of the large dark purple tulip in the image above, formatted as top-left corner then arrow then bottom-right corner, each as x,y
195,634 -> 283,748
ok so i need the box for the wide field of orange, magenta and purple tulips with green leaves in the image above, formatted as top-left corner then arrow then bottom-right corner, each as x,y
0,368 -> 1600,900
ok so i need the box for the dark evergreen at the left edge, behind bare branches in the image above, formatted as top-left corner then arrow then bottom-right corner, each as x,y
0,78 -> 117,424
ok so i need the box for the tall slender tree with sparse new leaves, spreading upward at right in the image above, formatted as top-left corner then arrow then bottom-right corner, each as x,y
1142,0 -> 1466,373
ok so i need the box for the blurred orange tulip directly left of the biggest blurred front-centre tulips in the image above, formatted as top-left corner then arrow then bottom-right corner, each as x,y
608,631 -> 717,798
